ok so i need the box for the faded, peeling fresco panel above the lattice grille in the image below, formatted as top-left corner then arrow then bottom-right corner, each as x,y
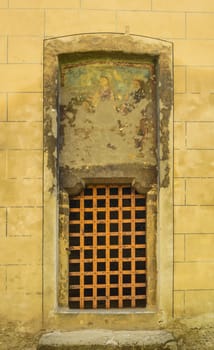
59,56 -> 157,174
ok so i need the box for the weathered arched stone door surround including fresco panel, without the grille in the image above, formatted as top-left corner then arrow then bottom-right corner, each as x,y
43,33 -> 173,329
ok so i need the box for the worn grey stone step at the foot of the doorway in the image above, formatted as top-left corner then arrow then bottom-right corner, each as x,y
37,329 -> 177,350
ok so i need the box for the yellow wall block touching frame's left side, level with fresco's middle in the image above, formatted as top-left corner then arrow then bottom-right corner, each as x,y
8,93 -> 42,122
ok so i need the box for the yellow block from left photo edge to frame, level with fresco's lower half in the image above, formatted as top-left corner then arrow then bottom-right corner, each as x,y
0,122 -> 43,149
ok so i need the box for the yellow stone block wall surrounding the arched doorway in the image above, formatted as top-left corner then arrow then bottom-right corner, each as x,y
0,0 -> 214,328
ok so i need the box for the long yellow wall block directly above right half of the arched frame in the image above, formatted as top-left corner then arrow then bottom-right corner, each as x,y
118,11 -> 185,39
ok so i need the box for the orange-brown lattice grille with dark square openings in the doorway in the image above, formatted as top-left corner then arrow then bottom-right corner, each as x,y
69,185 -> 146,309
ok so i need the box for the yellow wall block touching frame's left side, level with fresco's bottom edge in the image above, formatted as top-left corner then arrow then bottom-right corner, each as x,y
8,150 -> 42,179
